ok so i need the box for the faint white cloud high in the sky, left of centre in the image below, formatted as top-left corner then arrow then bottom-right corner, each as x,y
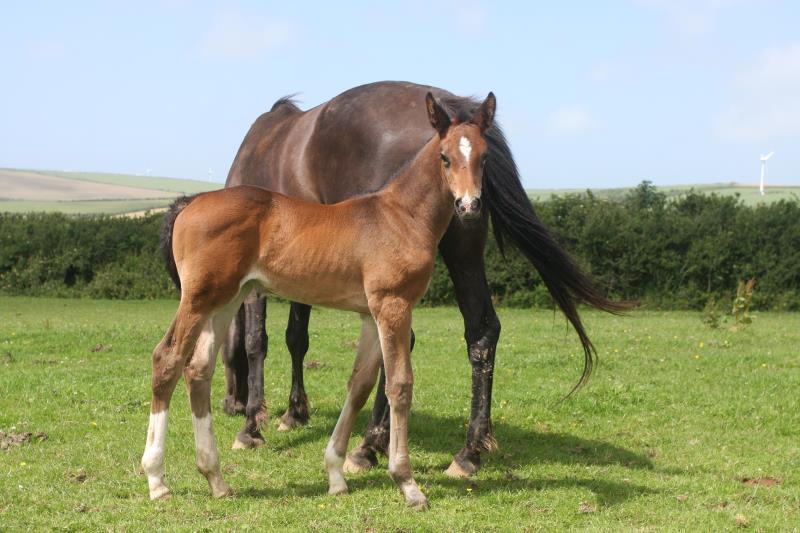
202,11 -> 294,60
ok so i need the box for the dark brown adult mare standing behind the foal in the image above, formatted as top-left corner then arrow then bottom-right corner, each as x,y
223,82 -> 619,476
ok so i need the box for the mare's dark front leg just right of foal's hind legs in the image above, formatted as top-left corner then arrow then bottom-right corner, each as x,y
233,290 -> 267,449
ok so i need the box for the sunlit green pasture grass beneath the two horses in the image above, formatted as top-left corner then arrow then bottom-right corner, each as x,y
0,298 -> 800,531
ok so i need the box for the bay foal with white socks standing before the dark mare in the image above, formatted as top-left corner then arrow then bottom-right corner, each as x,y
142,93 -> 495,508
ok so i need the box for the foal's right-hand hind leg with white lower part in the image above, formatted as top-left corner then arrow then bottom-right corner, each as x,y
183,302 -> 241,498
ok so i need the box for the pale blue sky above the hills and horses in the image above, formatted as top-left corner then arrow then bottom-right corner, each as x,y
0,0 -> 800,188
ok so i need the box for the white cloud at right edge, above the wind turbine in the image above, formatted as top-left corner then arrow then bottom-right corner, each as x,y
718,43 -> 800,141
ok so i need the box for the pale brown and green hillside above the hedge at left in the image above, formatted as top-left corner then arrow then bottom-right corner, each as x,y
0,169 -> 222,214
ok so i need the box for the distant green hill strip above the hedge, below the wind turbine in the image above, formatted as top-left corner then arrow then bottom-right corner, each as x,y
528,182 -> 800,205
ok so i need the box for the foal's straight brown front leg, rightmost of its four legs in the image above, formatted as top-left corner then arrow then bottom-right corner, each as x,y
370,297 -> 428,509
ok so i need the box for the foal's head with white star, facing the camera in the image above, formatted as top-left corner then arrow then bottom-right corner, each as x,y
425,93 -> 496,220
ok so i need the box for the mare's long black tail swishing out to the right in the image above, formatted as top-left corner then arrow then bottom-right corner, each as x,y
484,125 -> 630,394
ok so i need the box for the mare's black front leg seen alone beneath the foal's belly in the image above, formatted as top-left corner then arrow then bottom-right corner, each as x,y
278,302 -> 311,431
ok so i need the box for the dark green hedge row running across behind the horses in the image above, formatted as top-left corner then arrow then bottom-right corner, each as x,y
0,182 -> 800,310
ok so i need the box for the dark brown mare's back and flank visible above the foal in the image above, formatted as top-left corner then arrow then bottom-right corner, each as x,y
226,82 -> 462,203
